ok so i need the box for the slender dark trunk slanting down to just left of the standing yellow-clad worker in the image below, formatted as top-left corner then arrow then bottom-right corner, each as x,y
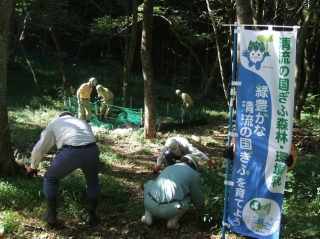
41,0 -> 72,96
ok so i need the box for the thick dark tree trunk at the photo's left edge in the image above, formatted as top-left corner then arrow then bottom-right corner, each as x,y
0,0 -> 16,176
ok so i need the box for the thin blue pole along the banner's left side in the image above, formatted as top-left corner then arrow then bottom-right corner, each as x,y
222,22 -> 238,239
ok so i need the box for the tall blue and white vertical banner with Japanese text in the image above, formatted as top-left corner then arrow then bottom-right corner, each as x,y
228,29 -> 296,239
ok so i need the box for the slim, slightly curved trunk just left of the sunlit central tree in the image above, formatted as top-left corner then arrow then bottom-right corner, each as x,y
123,0 -> 138,107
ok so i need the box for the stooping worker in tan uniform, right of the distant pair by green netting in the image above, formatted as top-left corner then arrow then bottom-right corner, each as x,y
96,85 -> 114,119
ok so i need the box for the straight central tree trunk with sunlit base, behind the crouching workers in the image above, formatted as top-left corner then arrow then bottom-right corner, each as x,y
141,0 -> 157,139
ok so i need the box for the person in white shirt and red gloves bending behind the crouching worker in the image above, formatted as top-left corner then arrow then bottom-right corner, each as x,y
153,137 -> 215,173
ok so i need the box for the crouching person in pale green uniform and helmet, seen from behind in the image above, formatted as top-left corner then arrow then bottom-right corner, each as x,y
141,154 -> 205,230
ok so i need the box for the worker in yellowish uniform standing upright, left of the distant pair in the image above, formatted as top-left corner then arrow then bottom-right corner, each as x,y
77,77 -> 97,123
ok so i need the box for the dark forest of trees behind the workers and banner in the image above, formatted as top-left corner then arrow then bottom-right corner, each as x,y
0,0 -> 320,236
